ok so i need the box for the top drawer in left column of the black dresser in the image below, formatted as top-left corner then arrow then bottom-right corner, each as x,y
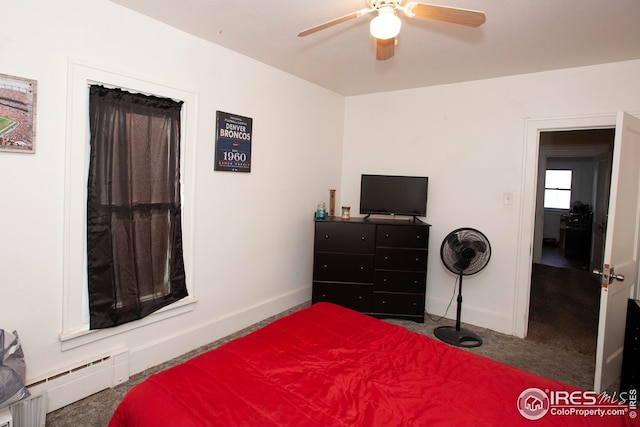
314,221 -> 376,254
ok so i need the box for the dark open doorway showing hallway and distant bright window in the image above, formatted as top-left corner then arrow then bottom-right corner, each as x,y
527,128 -> 615,359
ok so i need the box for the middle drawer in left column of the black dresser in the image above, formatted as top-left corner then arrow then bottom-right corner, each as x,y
313,252 -> 375,283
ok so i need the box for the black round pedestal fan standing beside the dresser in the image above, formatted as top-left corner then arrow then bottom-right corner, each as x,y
434,228 -> 491,347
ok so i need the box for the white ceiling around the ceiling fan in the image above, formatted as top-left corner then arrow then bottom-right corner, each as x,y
111,0 -> 640,96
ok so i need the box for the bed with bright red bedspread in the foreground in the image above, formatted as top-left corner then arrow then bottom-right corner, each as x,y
109,303 -> 635,427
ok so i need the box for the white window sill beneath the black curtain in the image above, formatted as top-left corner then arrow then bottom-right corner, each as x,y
58,296 -> 198,351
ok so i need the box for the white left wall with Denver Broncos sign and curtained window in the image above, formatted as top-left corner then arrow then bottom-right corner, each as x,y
0,0 -> 344,410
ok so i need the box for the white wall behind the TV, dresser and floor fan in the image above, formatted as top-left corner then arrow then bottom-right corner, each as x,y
342,61 -> 640,334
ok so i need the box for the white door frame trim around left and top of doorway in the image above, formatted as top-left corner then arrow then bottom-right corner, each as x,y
513,113 -> 616,338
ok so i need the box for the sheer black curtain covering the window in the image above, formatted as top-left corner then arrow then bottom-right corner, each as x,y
87,86 -> 187,329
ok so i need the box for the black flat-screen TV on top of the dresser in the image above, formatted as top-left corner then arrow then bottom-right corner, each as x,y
360,175 -> 429,216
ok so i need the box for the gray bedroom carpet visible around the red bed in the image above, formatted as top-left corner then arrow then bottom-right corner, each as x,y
46,290 -> 595,427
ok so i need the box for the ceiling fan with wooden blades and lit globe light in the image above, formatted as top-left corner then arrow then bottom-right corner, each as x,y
298,0 -> 486,60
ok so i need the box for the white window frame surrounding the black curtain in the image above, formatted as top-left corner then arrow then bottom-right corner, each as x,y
58,59 -> 198,351
